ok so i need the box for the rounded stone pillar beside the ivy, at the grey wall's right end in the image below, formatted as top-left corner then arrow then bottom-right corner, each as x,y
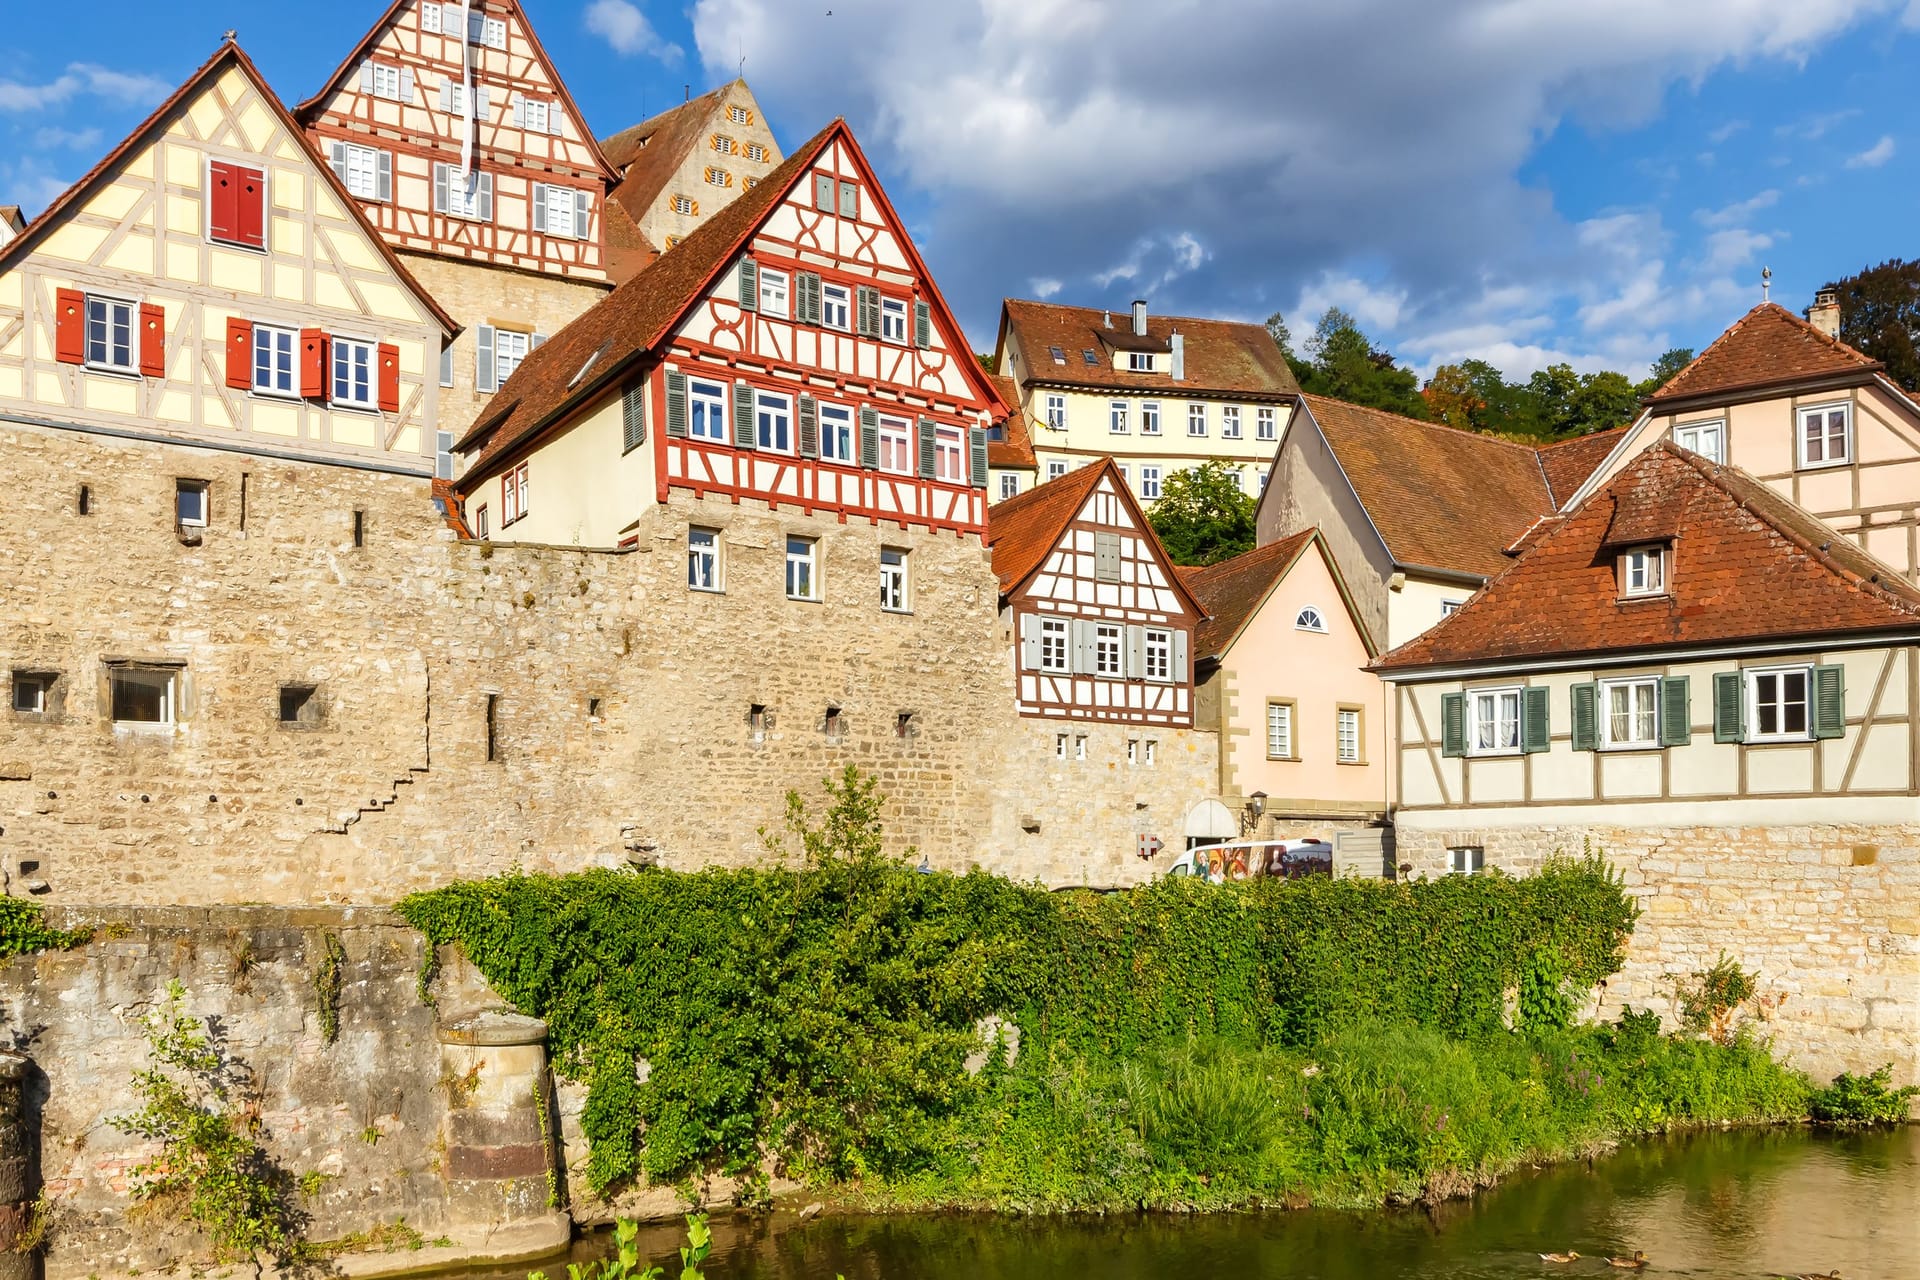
437,1013 -> 561,1228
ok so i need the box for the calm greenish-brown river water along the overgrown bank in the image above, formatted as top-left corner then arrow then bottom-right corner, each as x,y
488,1126 -> 1920,1280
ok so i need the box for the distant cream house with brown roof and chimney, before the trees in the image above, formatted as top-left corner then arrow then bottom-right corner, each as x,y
991,297 -> 1300,507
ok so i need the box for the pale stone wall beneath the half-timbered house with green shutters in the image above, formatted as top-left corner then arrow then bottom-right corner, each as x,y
1398,825 -> 1920,1082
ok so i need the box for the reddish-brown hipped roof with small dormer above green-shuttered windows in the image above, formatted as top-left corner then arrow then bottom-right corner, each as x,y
1375,441 -> 1920,672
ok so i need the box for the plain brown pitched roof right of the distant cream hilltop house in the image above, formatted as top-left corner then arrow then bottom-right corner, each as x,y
1302,395 -> 1553,576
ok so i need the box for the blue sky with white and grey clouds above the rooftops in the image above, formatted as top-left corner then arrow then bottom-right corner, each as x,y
0,0 -> 1920,376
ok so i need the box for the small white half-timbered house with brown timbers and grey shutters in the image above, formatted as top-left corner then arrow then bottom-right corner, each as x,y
991,459 -> 1202,729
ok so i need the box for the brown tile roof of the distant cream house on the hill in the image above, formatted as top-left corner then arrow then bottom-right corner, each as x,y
1000,297 -> 1300,395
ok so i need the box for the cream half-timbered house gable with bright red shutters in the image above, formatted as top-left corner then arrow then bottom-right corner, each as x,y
0,42 -> 455,479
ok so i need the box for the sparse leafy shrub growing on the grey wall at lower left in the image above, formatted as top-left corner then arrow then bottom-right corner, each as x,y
108,983 -> 300,1263
